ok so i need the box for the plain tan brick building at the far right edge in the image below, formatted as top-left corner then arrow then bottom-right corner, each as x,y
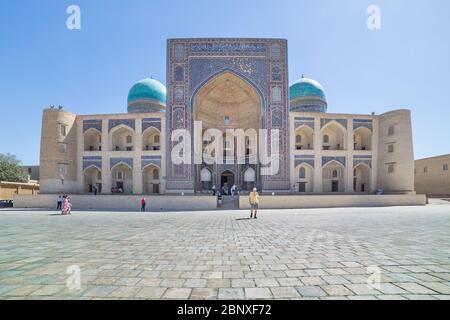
415,154 -> 450,197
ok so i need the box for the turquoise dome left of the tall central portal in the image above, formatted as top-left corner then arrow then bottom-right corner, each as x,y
128,79 -> 166,112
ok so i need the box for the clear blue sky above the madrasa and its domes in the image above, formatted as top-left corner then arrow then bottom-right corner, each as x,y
0,0 -> 450,164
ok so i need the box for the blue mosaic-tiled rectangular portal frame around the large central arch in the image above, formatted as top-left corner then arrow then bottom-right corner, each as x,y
166,39 -> 290,190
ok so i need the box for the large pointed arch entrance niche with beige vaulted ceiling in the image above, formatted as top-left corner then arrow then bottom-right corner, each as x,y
192,71 -> 264,191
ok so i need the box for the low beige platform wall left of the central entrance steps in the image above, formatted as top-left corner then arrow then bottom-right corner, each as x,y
14,194 -> 217,211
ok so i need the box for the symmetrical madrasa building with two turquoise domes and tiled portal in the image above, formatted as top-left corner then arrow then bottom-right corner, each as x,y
33,38 -> 415,208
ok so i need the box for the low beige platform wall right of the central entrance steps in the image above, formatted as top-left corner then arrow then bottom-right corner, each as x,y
239,194 -> 426,209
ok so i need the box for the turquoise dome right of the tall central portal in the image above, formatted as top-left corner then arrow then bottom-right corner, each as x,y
289,78 -> 327,112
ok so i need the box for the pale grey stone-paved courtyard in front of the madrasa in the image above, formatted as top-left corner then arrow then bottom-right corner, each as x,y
0,201 -> 450,299
